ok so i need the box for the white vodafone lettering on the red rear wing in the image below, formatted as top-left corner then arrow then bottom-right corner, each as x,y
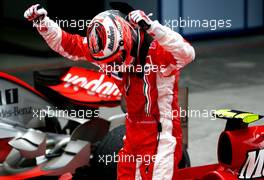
62,73 -> 121,96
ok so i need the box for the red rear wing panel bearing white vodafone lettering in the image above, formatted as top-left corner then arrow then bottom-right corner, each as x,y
49,67 -> 121,106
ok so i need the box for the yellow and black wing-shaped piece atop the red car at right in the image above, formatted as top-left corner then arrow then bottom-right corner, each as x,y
213,109 -> 264,130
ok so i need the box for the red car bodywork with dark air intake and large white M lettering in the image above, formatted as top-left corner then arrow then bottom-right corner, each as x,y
177,126 -> 264,180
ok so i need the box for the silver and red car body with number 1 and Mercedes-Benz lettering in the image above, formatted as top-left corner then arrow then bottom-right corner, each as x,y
0,69 -> 120,179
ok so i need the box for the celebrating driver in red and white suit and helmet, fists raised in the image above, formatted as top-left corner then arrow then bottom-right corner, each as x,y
24,4 -> 195,180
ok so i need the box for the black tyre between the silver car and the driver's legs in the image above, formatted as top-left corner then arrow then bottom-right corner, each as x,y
91,125 -> 125,180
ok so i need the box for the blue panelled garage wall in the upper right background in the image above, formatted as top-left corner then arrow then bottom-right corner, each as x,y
159,0 -> 264,37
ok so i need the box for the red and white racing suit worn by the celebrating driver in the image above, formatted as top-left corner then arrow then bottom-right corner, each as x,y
38,17 -> 195,180
